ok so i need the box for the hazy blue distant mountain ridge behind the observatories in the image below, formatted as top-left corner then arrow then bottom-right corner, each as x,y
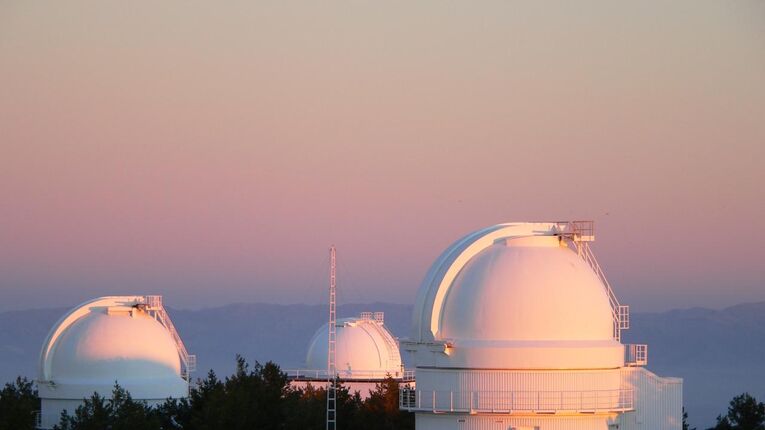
0,302 -> 765,428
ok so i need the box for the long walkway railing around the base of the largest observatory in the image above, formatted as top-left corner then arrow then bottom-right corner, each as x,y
399,388 -> 634,414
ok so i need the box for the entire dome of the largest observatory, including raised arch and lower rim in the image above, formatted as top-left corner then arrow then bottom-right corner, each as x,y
408,223 -> 624,369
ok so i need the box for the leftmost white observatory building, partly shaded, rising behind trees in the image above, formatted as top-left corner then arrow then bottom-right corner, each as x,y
37,296 -> 196,429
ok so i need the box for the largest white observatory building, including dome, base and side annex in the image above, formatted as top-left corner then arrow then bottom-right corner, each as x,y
400,221 -> 682,430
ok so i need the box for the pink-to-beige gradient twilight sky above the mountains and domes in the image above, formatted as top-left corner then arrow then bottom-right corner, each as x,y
0,0 -> 765,311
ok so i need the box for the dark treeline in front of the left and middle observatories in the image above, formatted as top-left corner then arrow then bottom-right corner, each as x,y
0,357 -> 414,430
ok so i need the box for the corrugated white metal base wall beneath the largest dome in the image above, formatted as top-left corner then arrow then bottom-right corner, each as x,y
416,367 -> 683,430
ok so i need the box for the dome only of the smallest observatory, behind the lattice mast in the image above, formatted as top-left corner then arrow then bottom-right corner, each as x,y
306,312 -> 402,379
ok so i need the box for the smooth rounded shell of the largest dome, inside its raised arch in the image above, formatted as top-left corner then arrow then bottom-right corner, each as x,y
436,236 -> 613,341
